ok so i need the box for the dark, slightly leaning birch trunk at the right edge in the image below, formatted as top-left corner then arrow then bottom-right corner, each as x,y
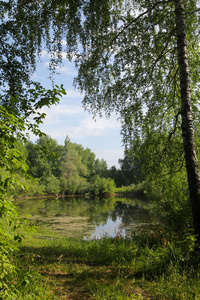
174,0 -> 200,243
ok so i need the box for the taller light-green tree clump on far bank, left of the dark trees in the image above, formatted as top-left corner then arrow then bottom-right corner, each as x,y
22,136 -> 115,195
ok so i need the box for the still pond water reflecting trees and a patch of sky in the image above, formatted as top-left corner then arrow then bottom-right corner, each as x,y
14,197 -> 152,239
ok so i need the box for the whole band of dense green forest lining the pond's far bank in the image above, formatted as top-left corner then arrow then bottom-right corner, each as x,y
9,135 -> 144,197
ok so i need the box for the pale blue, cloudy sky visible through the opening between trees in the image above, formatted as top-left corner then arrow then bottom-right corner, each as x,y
30,51 -> 124,168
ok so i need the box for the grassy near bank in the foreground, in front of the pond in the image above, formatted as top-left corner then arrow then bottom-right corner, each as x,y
5,228 -> 200,300
